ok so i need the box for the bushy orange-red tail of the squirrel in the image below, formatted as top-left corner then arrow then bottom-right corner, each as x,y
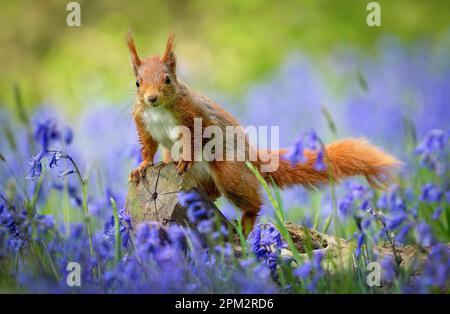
262,138 -> 401,188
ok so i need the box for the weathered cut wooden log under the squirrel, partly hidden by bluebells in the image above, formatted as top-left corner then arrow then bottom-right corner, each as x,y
125,163 -> 428,270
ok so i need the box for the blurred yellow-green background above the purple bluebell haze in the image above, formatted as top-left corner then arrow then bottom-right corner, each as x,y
0,0 -> 450,112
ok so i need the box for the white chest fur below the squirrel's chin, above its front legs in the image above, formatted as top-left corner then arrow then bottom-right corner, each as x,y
142,108 -> 178,151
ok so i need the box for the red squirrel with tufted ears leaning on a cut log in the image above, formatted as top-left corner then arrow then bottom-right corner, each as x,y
127,32 -> 400,235
